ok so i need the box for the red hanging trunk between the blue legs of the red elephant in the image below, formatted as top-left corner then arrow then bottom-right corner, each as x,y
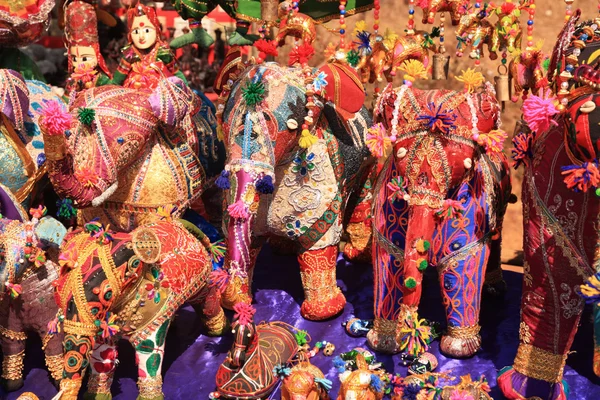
403,204 -> 436,309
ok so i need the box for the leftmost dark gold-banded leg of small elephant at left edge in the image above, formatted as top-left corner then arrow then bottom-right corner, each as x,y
0,296 -> 27,392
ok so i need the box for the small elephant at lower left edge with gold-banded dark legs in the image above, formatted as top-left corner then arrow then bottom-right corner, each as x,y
0,185 -> 67,392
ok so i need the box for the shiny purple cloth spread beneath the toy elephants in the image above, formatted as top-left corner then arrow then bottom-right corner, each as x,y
0,247 -> 600,400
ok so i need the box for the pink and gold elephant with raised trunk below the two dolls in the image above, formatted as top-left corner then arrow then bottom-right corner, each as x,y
42,77 -> 224,231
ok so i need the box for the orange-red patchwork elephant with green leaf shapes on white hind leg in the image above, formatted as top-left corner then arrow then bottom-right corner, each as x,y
50,217 -> 227,400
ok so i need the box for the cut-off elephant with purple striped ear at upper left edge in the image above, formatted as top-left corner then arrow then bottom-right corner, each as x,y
0,69 -> 66,206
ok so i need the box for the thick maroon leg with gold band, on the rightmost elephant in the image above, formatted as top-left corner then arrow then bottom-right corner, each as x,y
498,242 -> 584,400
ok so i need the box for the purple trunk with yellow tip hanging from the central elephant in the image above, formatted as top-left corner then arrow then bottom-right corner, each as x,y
222,168 -> 263,309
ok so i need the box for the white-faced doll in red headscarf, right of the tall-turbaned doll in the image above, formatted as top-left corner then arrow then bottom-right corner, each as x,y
113,4 -> 186,89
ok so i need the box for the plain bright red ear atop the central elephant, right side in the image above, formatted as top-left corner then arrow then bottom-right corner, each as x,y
316,62 -> 366,114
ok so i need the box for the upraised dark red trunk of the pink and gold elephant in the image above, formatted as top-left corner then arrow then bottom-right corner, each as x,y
41,124 -> 116,208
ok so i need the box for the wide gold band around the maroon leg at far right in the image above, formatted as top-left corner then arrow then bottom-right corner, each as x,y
514,343 -> 567,383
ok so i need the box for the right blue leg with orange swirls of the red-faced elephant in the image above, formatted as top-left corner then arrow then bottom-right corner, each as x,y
439,244 -> 490,358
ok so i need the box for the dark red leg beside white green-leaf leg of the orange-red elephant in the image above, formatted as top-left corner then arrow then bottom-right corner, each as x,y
83,342 -> 118,400
